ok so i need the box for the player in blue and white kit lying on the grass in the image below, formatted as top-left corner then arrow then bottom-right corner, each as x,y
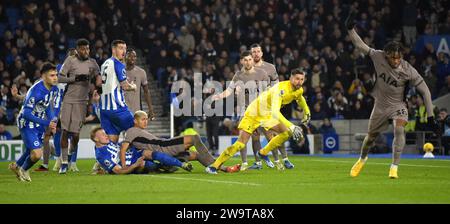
91,127 -> 192,174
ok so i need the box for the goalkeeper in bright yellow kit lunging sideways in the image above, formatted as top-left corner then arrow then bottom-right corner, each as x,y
206,69 -> 311,174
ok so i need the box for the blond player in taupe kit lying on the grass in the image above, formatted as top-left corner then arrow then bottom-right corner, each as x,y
120,110 -> 240,172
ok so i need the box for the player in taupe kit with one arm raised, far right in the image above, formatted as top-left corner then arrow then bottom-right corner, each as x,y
345,12 -> 438,178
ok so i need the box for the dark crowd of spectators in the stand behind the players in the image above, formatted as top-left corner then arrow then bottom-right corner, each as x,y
0,0 -> 450,136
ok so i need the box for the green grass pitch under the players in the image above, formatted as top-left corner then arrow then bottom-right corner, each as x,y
0,156 -> 450,204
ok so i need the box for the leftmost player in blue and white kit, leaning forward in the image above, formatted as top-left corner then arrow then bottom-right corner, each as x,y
9,63 -> 58,181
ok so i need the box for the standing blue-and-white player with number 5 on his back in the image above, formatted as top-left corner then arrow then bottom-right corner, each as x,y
100,40 -> 136,143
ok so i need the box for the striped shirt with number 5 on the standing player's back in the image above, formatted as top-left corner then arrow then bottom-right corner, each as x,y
100,57 -> 128,111
